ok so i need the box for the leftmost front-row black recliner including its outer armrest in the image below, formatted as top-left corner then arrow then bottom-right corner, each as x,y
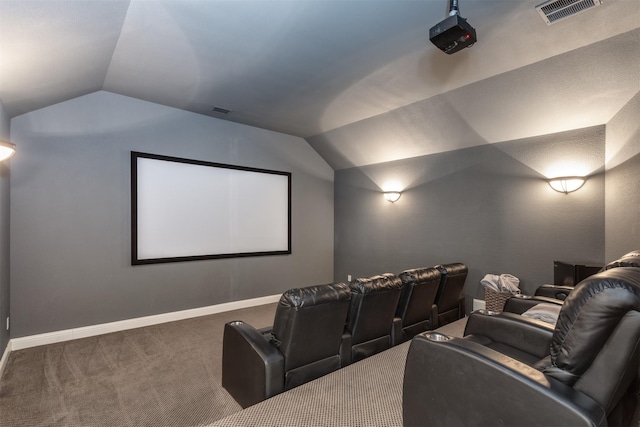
222,283 -> 351,408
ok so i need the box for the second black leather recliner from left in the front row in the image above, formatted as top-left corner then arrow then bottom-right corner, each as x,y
340,273 -> 402,365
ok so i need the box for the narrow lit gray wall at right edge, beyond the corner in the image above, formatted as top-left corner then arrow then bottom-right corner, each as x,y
605,93 -> 640,260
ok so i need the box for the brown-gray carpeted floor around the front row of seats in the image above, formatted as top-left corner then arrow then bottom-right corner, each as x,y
0,304 -> 464,427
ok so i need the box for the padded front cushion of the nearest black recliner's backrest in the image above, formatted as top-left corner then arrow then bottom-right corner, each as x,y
545,267 -> 640,385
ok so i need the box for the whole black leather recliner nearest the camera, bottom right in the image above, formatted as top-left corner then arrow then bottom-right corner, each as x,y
403,267 -> 640,426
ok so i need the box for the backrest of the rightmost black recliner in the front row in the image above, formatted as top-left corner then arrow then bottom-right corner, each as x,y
435,263 -> 469,326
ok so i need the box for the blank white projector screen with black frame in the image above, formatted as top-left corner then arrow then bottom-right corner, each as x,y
131,151 -> 291,265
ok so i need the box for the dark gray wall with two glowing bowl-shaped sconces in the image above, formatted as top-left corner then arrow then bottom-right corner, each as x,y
334,126 -> 605,304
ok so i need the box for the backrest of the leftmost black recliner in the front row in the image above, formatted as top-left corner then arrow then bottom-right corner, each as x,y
272,283 -> 351,388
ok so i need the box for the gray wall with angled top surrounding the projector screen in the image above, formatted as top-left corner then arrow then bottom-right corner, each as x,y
11,92 -> 334,337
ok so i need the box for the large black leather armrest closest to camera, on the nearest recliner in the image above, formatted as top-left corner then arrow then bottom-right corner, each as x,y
402,332 -> 607,427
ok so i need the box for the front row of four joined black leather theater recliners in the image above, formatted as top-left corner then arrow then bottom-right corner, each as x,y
222,263 -> 468,407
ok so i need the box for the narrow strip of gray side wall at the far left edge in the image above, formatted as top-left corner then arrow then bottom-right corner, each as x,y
0,101 -> 11,357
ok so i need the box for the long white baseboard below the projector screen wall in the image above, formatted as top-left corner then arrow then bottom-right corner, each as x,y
9,294 -> 280,352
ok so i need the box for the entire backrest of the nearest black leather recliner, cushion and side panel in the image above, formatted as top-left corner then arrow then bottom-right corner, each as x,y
543,267 -> 640,414
